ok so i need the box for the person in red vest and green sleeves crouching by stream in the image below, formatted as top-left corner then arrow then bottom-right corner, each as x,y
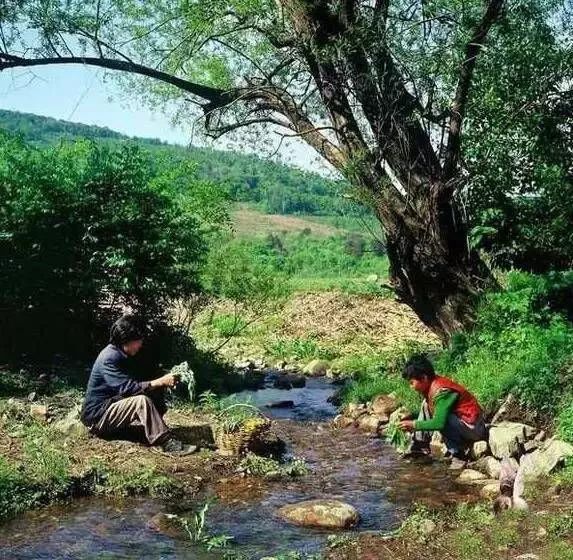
399,354 -> 487,460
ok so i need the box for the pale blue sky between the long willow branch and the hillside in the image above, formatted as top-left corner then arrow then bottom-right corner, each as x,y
0,65 -> 328,174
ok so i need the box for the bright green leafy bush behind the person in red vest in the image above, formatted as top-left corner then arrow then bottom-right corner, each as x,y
437,272 -> 573,414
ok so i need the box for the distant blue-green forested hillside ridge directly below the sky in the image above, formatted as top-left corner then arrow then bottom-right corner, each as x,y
0,110 -> 368,216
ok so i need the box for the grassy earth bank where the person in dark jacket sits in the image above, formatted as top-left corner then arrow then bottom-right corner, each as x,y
0,367 -> 236,521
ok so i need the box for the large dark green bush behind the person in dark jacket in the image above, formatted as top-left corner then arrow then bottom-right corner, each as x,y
0,136 -> 227,354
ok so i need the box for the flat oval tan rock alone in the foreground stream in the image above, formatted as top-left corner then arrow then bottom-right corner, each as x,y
278,500 -> 360,529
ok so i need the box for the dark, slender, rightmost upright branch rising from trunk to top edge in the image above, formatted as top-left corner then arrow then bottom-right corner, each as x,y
444,0 -> 504,177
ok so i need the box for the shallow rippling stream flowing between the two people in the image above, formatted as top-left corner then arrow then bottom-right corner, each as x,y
0,378 -> 472,560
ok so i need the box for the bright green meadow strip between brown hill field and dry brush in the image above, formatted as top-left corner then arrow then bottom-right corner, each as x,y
204,229 -> 388,300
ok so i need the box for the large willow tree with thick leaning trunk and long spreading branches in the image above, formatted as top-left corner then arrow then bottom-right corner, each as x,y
0,0 -> 563,339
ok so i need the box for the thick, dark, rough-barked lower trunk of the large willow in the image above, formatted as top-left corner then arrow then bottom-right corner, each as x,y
378,182 -> 495,343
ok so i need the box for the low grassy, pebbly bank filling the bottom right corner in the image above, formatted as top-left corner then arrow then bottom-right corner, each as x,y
324,480 -> 573,560
